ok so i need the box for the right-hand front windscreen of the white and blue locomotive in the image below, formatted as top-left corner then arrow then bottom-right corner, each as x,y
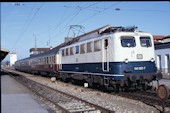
140,37 -> 152,47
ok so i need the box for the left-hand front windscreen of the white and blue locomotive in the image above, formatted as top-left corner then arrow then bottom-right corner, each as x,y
121,36 -> 136,47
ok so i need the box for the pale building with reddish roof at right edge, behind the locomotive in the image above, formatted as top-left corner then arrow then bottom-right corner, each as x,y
155,35 -> 170,78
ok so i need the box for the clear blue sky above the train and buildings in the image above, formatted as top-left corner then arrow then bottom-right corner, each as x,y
1,1 -> 170,61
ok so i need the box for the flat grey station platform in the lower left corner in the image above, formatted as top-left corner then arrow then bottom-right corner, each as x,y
1,75 -> 48,113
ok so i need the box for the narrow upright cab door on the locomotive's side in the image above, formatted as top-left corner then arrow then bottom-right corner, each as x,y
102,38 -> 109,72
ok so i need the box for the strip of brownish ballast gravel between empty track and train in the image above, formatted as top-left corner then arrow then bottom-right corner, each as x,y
25,77 -> 160,113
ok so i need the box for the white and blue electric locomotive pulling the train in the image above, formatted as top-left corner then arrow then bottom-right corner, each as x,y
59,26 -> 160,90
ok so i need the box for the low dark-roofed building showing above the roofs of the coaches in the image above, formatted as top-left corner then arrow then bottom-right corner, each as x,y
30,48 -> 52,56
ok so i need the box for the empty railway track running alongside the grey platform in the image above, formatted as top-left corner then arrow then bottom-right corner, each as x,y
4,70 -> 114,113
